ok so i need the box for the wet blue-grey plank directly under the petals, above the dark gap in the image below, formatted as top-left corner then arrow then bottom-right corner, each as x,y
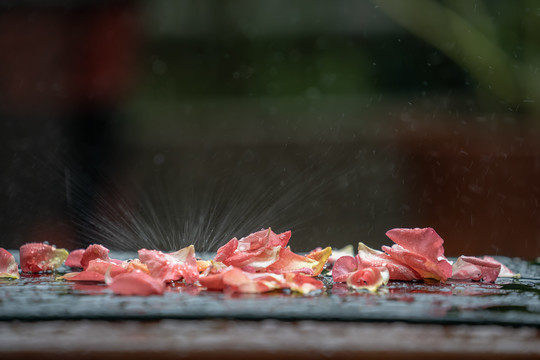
4,252 -> 540,327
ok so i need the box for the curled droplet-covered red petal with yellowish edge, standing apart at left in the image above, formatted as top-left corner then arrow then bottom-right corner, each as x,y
19,243 -> 68,273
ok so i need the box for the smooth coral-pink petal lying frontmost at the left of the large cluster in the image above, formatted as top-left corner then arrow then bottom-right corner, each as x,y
109,270 -> 165,296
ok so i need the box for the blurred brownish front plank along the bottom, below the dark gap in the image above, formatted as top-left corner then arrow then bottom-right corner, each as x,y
0,320 -> 540,359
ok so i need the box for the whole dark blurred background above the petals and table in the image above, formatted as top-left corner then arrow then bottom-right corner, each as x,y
0,0 -> 540,258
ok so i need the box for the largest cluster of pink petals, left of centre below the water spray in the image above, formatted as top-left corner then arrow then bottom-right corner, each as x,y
54,229 -> 332,295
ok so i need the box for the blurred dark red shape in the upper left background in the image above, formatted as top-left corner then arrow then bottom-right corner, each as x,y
0,1 -> 139,115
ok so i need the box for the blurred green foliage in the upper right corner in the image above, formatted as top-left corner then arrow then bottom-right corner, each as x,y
373,0 -> 540,113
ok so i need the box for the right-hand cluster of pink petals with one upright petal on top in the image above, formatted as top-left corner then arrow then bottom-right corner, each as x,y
332,228 -> 519,291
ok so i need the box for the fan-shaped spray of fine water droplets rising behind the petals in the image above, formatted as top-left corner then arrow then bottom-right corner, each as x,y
64,155 -> 350,251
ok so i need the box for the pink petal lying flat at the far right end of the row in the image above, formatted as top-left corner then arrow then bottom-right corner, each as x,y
452,256 -> 501,282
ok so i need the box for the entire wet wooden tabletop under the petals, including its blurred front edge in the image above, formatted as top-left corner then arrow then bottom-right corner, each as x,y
0,253 -> 540,358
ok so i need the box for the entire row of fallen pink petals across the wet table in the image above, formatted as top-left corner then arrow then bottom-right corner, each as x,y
4,228 -> 519,296
